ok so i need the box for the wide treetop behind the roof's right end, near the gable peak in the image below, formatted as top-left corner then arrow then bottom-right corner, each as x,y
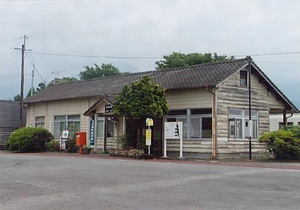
155,52 -> 235,70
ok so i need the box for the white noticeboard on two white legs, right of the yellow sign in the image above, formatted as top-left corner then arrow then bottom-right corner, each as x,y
163,122 -> 183,158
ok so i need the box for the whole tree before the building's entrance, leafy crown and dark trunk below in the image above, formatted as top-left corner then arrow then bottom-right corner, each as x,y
113,77 -> 169,149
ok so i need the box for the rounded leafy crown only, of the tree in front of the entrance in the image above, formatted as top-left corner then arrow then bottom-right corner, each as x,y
113,77 -> 169,119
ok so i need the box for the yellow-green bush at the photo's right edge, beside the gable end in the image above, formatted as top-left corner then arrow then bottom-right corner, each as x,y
259,126 -> 300,160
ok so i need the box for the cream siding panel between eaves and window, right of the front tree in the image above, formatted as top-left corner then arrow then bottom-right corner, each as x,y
167,89 -> 212,110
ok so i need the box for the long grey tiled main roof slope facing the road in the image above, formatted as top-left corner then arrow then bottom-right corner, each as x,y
25,59 -> 248,103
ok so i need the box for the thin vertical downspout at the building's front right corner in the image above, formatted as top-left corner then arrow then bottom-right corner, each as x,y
206,86 -> 217,159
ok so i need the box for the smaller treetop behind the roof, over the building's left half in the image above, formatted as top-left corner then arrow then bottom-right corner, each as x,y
79,63 -> 122,80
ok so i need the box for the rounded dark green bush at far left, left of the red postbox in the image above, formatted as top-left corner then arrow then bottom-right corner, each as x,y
5,127 -> 54,152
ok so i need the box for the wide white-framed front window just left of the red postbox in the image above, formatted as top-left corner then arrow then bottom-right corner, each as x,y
54,115 -> 80,138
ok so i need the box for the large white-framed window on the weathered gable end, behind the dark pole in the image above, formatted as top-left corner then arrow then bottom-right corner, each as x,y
228,109 -> 258,140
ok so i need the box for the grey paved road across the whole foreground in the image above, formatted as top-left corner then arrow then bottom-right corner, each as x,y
0,153 -> 300,210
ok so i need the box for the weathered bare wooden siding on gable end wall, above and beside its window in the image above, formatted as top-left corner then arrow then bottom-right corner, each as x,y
217,69 -> 284,140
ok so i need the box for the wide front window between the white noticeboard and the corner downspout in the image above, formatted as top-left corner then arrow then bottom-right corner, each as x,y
167,109 -> 212,140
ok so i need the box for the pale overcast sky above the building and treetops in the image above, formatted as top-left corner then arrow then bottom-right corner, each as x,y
0,0 -> 300,108
